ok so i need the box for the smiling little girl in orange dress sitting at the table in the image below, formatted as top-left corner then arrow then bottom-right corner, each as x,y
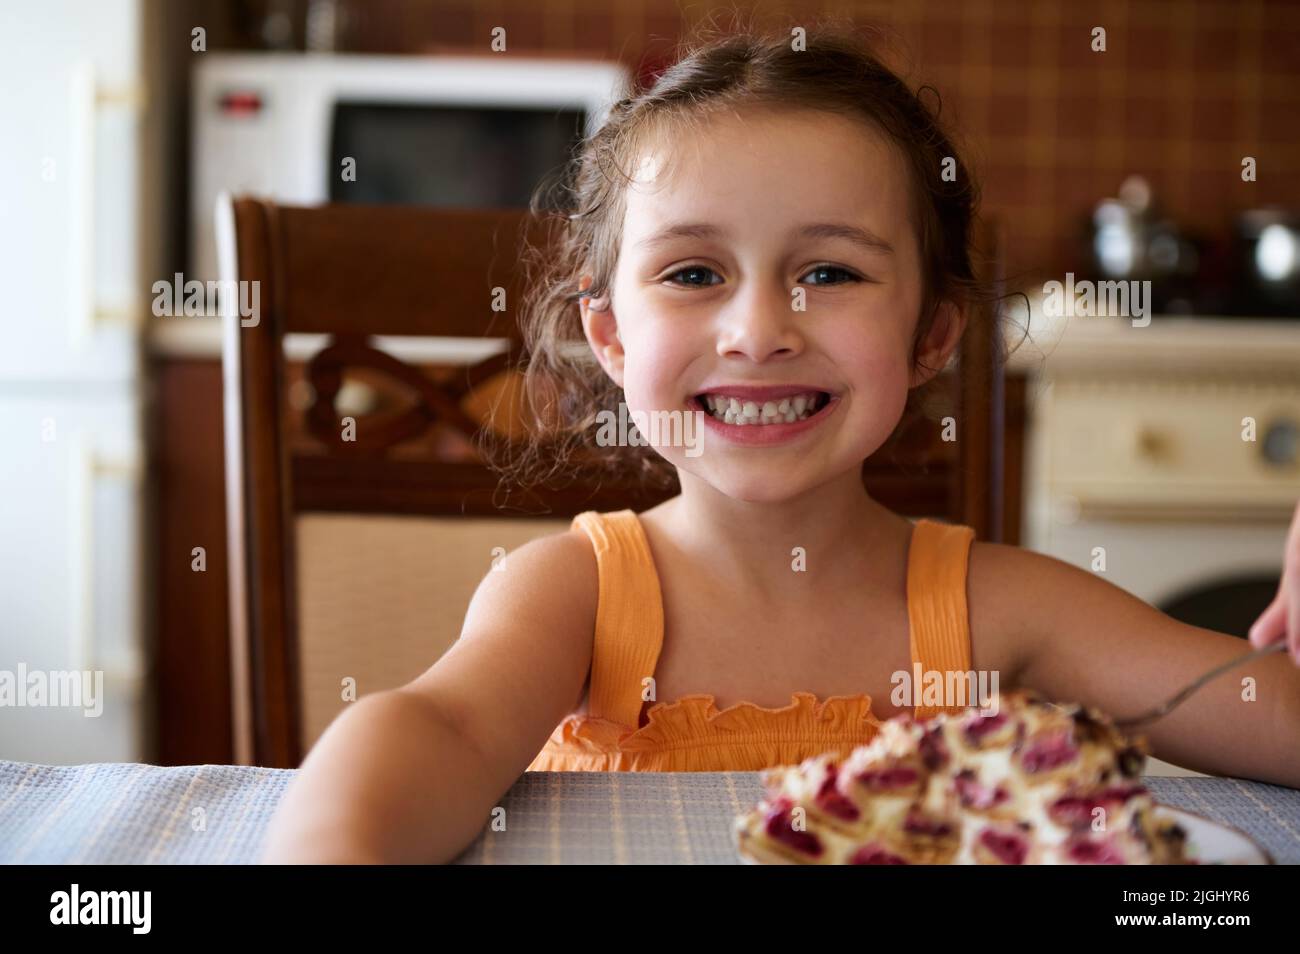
264,18 -> 1300,862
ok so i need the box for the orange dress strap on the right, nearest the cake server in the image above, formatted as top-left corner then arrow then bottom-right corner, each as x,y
907,520 -> 975,719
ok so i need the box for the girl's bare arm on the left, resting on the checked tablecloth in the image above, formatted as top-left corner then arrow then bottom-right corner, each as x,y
261,530 -> 597,863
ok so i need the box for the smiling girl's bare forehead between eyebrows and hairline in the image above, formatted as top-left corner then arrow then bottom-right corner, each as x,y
623,110 -> 911,250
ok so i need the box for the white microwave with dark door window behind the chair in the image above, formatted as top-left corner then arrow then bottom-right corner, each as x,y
187,53 -> 632,283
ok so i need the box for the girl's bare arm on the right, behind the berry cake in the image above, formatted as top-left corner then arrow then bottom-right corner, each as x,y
970,543 -> 1300,788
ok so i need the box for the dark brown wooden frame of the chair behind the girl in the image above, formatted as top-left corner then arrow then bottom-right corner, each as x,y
217,198 -> 1002,767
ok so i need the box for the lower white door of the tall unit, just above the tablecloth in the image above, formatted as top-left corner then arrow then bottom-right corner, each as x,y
0,389 -> 151,764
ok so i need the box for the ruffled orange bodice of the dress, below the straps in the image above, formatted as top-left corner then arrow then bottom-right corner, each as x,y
528,691 -> 880,772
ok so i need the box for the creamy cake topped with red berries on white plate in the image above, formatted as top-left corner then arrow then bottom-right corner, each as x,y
735,690 -> 1188,864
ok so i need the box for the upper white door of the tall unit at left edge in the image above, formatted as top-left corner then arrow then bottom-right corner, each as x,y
0,0 -> 150,381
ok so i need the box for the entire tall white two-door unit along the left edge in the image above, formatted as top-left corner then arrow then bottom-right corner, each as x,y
0,0 -> 150,763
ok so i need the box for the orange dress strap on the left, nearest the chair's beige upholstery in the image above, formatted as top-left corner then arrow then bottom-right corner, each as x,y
571,509 -> 663,729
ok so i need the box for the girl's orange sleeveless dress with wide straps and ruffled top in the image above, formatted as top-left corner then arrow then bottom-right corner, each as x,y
528,509 -> 975,772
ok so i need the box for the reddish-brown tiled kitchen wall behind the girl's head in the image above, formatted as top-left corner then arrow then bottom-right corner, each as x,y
297,0 -> 1300,280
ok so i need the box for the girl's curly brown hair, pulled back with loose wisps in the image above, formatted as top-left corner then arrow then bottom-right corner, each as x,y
481,17 -> 991,504
